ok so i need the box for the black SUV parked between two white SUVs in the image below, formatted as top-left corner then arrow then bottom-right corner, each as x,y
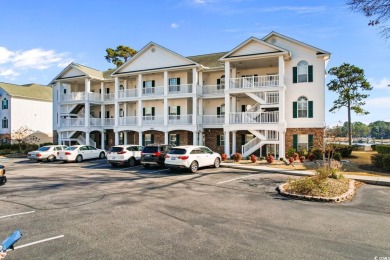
141,144 -> 172,168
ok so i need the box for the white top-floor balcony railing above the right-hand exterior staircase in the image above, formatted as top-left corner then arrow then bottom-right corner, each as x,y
229,75 -> 279,89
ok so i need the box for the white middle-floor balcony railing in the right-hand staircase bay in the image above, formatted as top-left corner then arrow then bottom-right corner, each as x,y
229,111 -> 279,124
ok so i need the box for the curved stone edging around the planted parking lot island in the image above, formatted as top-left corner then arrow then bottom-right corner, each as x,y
276,179 -> 355,202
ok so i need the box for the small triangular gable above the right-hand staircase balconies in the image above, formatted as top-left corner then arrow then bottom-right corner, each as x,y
220,37 -> 289,60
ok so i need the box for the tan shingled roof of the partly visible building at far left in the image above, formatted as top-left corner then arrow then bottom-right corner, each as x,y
0,82 -> 53,101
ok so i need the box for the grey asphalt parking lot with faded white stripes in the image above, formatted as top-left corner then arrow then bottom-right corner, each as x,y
0,159 -> 390,259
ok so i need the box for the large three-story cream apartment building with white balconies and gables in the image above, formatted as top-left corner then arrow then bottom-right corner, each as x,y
51,32 -> 330,157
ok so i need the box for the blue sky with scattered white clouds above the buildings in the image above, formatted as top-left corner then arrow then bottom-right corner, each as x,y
0,0 -> 390,127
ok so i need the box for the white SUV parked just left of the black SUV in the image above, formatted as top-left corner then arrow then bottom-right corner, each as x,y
107,144 -> 144,167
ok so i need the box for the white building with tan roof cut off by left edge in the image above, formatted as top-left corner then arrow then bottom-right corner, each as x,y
0,82 -> 53,143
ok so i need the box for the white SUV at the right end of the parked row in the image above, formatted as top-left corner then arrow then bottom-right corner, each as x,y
165,145 -> 221,173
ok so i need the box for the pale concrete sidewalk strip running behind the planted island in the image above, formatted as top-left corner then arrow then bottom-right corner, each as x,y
221,163 -> 390,186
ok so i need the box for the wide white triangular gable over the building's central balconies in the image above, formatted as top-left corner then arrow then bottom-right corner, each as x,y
111,42 -> 199,76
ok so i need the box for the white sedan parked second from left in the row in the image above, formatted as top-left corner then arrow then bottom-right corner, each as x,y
57,145 -> 106,162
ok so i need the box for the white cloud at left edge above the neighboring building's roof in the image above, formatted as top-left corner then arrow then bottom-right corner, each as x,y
0,46 -> 72,80
